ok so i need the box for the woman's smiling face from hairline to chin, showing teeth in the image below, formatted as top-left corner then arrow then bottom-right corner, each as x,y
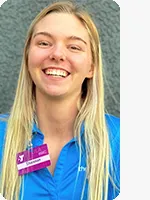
28,13 -> 93,97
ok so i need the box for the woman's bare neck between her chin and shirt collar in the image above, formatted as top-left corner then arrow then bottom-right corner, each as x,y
36,91 -> 79,138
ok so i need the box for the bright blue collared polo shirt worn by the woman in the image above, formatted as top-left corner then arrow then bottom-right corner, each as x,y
0,115 -> 120,200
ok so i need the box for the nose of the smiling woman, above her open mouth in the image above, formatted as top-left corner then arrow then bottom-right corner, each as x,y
49,45 -> 66,61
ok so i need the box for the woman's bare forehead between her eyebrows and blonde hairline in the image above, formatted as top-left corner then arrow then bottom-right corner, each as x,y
34,13 -> 89,42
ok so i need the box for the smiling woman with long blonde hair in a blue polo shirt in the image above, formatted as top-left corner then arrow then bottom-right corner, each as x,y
0,2 -> 119,200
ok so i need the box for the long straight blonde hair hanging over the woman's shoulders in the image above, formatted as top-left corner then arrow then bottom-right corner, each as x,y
0,2 -> 116,200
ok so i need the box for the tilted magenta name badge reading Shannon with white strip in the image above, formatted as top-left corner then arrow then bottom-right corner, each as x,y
17,144 -> 51,175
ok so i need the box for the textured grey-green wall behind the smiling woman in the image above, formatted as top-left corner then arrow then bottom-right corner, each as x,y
0,0 -> 120,117
